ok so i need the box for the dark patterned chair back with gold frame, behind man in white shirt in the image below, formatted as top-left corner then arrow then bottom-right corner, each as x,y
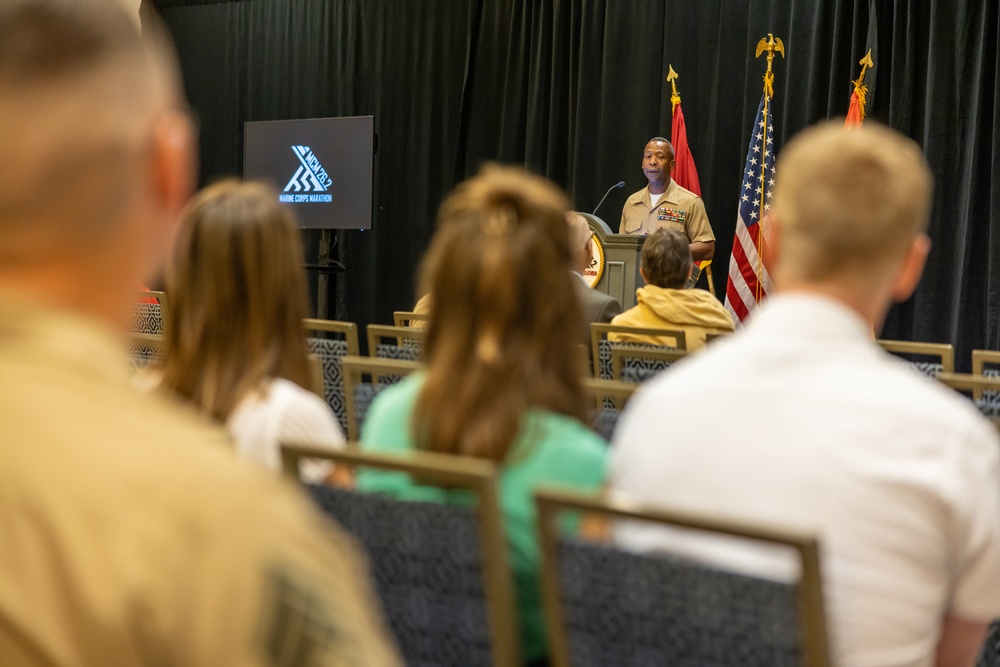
535,489 -> 830,667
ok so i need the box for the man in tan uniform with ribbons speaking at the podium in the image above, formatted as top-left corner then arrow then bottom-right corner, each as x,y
618,137 -> 715,262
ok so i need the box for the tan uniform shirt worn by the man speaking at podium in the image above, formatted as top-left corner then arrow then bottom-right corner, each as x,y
618,179 -> 715,243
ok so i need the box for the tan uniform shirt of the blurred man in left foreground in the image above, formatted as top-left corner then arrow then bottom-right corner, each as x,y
0,297 -> 399,667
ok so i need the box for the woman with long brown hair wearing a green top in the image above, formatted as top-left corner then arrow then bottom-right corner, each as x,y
359,166 -> 606,662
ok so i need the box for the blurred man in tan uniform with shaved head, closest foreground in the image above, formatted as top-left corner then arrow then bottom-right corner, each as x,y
0,0 -> 398,667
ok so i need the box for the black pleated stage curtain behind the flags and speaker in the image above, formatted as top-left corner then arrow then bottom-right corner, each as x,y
158,0 -> 1000,369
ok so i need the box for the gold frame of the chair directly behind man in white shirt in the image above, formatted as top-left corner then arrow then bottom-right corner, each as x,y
535,487 -> 831,667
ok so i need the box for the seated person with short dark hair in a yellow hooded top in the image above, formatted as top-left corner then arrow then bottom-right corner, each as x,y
608,229 -> 734,350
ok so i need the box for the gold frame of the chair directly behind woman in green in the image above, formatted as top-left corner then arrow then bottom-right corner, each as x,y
281,443 -> 521,667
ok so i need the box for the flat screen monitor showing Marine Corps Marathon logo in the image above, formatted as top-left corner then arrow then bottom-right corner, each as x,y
243,116 -> 375,229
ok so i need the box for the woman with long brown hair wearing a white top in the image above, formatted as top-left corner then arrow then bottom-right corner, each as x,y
156,180 -> 344,470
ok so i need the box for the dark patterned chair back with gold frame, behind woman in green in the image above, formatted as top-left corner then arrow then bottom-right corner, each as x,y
282,445 -> 520,667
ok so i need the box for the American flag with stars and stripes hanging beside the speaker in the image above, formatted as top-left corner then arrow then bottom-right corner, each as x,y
726,97 -> 774,322
